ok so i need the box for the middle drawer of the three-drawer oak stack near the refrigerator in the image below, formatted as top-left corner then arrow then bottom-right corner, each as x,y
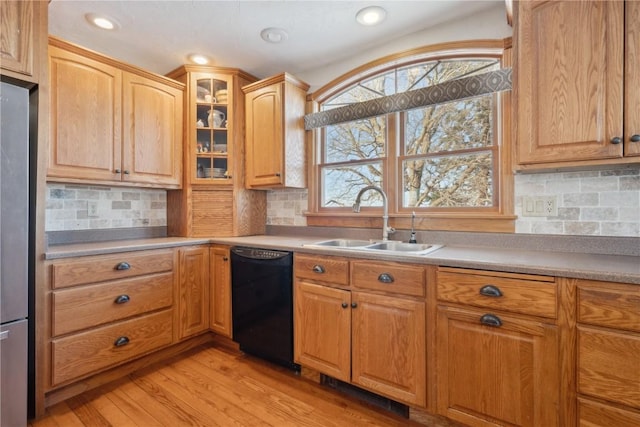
52,272 -> 173,336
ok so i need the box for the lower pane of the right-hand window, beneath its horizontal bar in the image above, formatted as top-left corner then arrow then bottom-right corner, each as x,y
402,152 -> 493,208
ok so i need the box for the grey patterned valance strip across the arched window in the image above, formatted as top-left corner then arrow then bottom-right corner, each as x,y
304,68 -> 511,130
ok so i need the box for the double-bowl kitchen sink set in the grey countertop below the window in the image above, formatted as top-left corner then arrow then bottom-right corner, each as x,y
304,239 -> 442,255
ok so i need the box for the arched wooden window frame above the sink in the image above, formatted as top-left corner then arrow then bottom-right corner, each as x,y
305,38 -> 516,232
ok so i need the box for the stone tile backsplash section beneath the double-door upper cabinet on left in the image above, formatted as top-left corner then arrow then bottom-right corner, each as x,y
45,183 -> 167,231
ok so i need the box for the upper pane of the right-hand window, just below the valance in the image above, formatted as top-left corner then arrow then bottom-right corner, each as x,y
405,95 -> 493,155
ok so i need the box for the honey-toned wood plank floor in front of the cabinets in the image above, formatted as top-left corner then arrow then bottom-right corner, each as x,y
29,345 -> 457,427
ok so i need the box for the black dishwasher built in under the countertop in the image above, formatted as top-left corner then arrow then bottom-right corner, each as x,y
231,246 -> 300,371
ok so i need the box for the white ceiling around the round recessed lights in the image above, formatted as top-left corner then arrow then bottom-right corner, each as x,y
49,0 -> 504,78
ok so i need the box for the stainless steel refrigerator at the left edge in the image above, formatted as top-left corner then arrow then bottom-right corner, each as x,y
0,82 -> 32,427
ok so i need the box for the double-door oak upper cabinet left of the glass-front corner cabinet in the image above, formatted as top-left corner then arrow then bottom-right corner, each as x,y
47,37 -> 184,188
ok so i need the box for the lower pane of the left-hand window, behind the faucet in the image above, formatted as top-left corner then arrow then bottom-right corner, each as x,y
321,162 -> 382,207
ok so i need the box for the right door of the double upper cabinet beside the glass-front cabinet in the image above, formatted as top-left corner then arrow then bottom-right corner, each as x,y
122,72 -> 183,187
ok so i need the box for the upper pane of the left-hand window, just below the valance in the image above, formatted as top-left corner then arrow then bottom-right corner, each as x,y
324,117 -> 387,163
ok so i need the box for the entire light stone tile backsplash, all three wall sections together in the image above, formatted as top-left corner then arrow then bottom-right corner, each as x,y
46,166 -> 640,237
